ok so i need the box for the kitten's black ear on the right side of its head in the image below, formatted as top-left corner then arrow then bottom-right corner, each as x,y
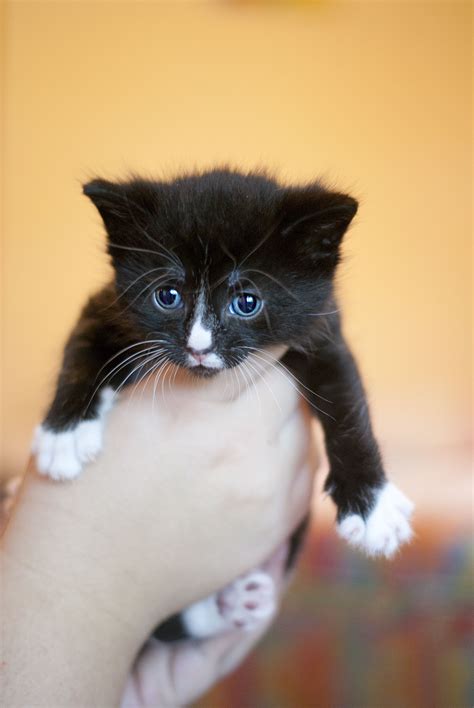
281,184 -> 358,257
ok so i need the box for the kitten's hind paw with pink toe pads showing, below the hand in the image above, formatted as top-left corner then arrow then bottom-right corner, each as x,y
217,570 -> 277,631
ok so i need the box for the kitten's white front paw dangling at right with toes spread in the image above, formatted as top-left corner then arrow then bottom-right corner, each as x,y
338,482 -> 414,558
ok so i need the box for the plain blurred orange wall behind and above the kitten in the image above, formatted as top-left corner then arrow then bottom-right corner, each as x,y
2,0 -> 472,472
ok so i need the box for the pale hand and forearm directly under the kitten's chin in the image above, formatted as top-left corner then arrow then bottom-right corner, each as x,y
2,362 -> 314,708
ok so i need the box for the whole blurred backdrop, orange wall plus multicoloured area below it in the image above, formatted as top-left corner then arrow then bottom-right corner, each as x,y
0,0 -> 474,708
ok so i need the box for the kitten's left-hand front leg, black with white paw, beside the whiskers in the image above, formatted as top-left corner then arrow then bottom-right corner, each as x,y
32,304 -> 122,480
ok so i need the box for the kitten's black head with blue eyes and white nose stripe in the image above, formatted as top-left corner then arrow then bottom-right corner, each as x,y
84,169 -> 357,375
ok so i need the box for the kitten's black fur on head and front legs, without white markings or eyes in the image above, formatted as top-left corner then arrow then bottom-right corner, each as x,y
39,169 -> 385,640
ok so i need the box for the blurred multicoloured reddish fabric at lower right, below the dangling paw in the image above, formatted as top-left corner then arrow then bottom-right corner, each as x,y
198,528 -> 474,708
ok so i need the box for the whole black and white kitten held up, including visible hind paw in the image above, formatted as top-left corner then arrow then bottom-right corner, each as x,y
34,169 -> 412,636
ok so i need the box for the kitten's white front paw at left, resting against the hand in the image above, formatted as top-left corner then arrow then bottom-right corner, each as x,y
32,418 -> 103,480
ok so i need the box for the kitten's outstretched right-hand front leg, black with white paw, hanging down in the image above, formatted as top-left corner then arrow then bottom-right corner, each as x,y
284,338 -> 413,557
